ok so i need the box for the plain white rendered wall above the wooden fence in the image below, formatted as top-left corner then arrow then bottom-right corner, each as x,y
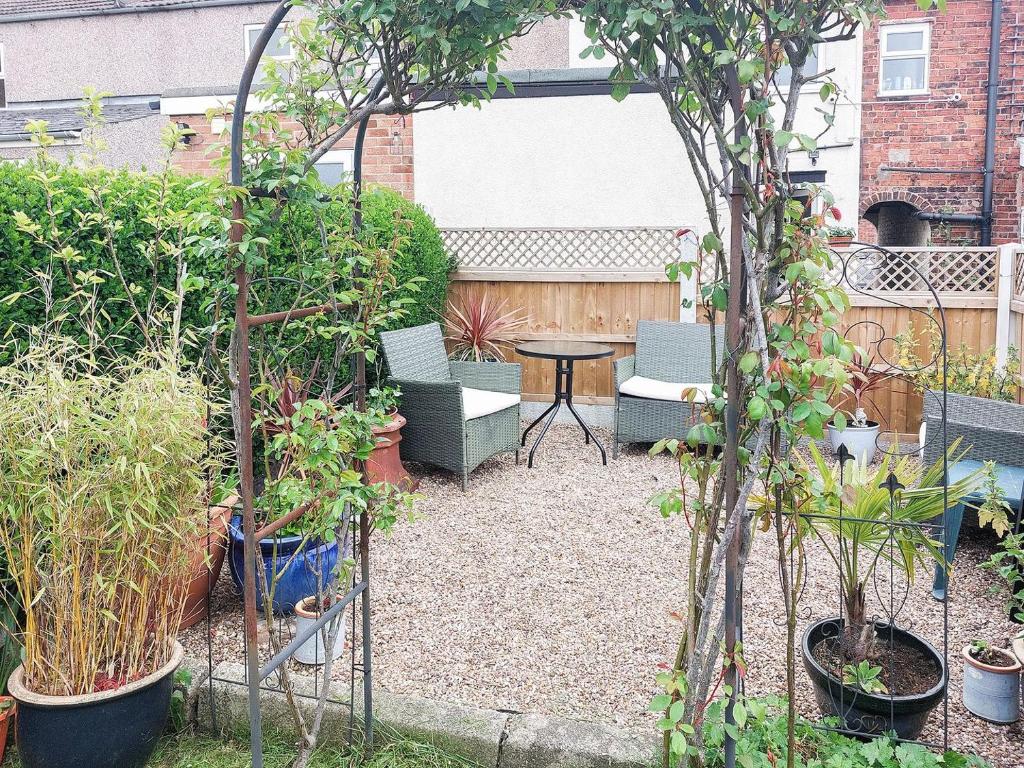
414,28 -> 861,231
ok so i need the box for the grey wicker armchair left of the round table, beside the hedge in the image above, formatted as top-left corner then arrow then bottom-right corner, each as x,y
381,323 -> 522,490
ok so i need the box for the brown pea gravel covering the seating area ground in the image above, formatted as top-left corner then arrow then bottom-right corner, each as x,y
184,425 -> 1024,768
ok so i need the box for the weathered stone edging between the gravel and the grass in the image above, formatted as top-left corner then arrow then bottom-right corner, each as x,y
183,658 -> 658,768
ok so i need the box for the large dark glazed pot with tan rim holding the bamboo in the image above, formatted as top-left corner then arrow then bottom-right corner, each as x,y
8,643 -> 184,768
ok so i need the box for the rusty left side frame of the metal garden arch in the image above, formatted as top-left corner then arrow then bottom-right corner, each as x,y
229,0 -> 376,768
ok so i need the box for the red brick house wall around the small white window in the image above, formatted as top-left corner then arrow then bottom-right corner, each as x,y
860,0 -> 1024,245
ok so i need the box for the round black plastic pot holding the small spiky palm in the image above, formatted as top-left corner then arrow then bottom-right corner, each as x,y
802,617 -> 949,739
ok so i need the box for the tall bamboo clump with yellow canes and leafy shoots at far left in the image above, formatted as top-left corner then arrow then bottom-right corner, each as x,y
0,103 -> 223,695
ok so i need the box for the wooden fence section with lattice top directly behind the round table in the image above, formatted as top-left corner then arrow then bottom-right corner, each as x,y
441,227 -> 681,404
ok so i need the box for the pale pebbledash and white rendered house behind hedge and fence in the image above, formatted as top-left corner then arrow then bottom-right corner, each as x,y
0,0 -> 864,231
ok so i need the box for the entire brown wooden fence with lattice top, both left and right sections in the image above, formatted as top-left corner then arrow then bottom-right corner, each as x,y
442,227 -> 1024,434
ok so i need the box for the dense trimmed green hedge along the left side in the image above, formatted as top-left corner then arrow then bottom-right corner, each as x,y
0,163 -> 454,364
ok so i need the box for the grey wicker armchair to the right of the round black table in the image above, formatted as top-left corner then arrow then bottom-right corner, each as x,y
612,321 -> 725,457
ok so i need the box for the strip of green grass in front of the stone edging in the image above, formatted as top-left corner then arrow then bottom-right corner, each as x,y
3,733 -> 475,768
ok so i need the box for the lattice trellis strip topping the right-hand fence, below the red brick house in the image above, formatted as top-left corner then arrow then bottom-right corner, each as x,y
831,248 -> 998,294
